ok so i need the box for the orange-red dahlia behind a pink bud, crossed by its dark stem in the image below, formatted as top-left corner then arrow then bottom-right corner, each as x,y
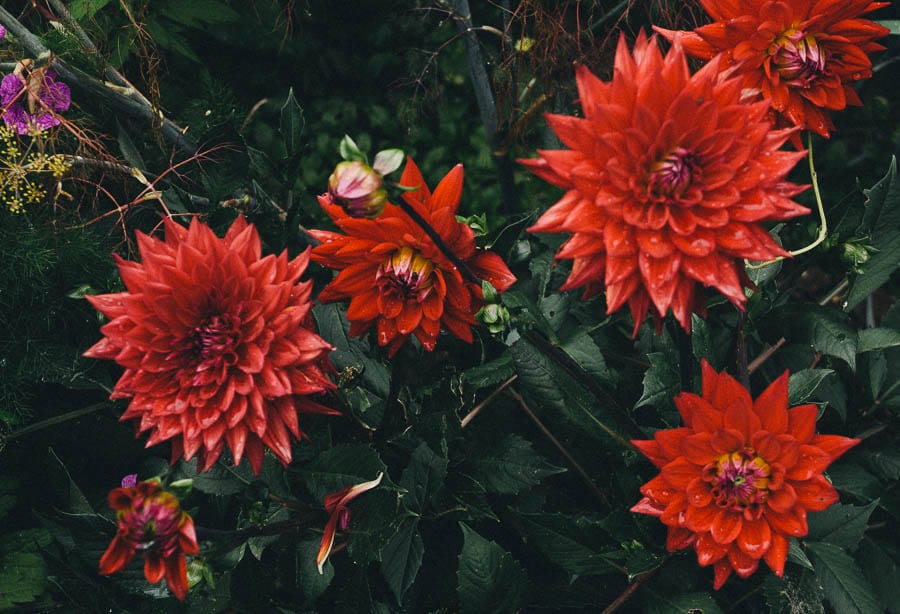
310,158 -> 516,356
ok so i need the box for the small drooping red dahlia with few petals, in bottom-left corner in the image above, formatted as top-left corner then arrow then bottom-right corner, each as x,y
100,482 -> 200,601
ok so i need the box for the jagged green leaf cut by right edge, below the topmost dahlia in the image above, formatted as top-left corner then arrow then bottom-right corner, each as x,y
844,158 -> 900,311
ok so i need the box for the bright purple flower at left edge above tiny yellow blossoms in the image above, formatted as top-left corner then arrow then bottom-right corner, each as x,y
0,70 -> 72,134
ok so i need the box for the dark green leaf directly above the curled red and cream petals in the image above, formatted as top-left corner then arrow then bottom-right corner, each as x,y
298,443 -> 387,501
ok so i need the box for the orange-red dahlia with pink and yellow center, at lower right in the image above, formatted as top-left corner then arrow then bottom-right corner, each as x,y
631,361 -> 859,589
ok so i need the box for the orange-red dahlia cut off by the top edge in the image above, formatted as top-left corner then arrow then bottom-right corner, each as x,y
655,0 -> 890,137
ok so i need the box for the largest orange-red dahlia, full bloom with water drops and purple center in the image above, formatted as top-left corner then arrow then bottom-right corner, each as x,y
521,32 -> 809,334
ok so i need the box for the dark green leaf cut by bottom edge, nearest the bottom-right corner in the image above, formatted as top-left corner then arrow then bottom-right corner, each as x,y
806,542 -> 882,614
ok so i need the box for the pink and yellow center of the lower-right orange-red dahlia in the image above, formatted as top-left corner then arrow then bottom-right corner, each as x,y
704,448 -> 771,511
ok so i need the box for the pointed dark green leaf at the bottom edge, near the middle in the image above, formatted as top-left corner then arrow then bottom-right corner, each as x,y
456,522 -> 528,614
